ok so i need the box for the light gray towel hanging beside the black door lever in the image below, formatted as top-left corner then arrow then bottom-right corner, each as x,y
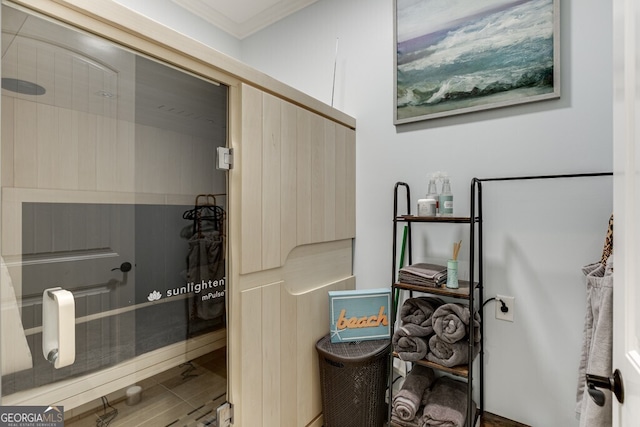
576,256 -> 613,427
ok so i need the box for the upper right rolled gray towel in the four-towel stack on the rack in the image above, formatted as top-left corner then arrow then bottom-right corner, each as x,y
432,303 -> 480,344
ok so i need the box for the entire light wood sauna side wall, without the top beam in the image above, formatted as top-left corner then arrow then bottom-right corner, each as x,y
229,84 -> 355,426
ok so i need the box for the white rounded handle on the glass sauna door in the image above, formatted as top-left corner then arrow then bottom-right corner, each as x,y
42,287 -> 76,369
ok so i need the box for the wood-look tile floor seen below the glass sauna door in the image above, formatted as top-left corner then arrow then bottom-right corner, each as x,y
65,348 -> 227,427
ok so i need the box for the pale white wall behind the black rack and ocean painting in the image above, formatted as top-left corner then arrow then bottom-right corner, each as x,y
110,0 -> 612,427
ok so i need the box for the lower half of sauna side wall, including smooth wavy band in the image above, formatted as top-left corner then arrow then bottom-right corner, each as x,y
230,239 -> 355,426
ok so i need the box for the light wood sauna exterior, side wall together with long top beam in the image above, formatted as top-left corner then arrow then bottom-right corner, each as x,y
2,0 -> 356,427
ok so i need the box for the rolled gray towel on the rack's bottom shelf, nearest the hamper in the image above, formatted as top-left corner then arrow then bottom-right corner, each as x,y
393,364 -> 435,421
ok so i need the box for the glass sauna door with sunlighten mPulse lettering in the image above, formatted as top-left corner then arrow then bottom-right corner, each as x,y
0,4 -> 227,422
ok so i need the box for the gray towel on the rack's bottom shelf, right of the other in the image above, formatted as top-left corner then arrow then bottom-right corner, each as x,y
420,377 -> 475,427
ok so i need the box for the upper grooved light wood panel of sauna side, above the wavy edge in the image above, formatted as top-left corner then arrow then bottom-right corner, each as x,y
240,85 -> 355,274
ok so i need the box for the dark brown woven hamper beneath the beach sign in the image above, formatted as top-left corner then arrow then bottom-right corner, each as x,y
316,335 -> 391,427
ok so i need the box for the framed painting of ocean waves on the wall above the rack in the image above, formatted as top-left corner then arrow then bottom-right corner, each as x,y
394,0 -> 560,125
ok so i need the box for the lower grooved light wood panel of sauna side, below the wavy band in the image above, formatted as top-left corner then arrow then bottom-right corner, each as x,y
235,270 -> 355,426
